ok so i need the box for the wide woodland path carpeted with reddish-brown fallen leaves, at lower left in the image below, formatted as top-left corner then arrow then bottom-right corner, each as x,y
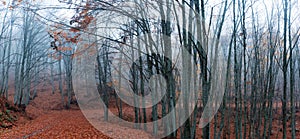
0,110 -> 151,139
